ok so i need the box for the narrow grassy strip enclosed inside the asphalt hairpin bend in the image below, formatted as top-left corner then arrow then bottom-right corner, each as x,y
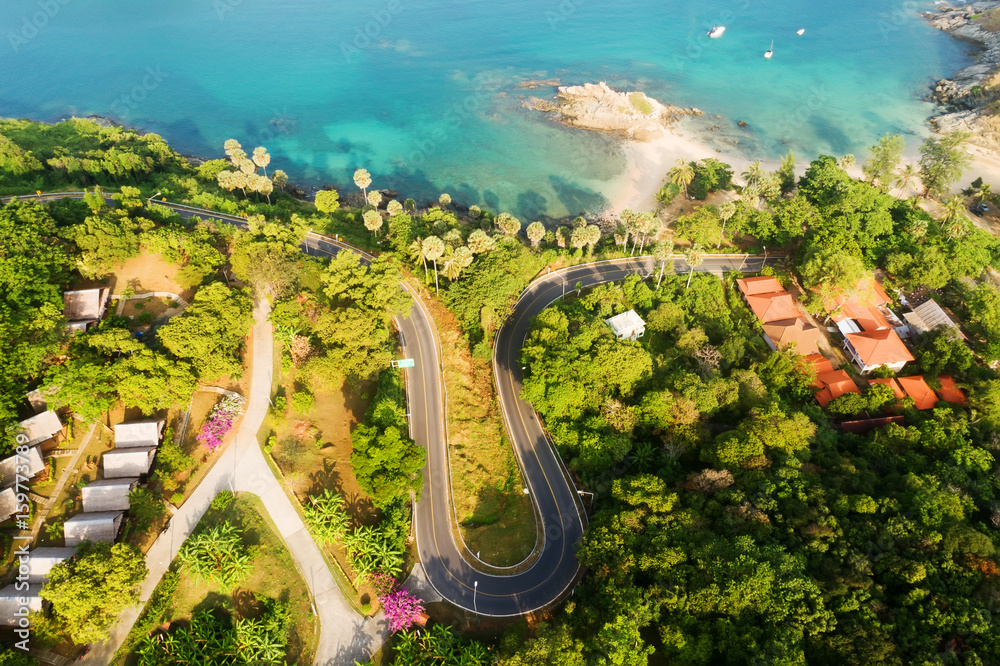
427,294 -> 537,567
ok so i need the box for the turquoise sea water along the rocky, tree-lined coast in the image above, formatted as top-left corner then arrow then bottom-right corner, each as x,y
0,0 -> 970,218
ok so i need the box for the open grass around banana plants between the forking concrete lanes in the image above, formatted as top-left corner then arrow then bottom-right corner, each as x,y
112,494 -> 315,665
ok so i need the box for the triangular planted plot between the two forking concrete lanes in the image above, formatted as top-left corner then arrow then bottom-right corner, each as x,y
112,491 -> 316,666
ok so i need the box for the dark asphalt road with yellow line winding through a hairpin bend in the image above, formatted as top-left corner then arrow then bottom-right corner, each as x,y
3,193 -> 765,617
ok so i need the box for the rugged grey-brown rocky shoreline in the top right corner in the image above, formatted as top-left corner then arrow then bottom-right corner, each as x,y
922,0 -> 1000,151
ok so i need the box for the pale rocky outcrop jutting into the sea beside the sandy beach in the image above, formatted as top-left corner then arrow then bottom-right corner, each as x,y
524,81 -> 703,141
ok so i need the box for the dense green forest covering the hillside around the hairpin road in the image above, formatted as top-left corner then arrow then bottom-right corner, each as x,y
0,116 -> 1000,666
